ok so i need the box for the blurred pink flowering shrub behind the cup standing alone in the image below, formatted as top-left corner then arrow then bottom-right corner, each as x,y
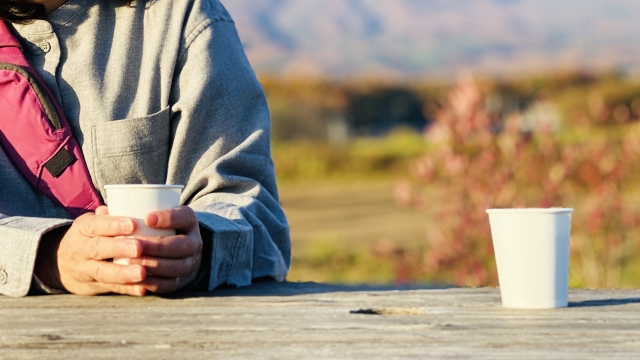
397,79 -> 640,287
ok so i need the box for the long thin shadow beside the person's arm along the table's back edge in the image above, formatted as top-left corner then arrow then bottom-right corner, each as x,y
168,282 -> 452,299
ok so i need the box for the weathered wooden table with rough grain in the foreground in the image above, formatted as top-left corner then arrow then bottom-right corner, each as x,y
0,283 -> 640,360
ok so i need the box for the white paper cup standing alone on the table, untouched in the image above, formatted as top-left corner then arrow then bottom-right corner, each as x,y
487,208 -> 573,309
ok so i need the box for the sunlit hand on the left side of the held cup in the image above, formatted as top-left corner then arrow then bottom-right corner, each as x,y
35,207 -> 147,296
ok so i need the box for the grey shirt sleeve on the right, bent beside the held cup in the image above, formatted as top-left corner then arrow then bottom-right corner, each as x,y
167,18 -> 291,290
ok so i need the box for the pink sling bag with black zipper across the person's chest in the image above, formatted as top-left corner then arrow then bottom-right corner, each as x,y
0,21 -> 102,218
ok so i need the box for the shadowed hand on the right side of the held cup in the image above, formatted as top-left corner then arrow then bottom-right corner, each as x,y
96,206 -> 202,293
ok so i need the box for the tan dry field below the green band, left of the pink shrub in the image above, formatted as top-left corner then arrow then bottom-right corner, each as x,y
280,180 -> 426,283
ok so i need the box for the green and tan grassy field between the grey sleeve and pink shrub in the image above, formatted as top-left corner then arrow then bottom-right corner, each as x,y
274,130 -> 448,284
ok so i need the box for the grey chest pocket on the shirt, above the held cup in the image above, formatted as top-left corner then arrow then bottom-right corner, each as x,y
91,108 -> 171,196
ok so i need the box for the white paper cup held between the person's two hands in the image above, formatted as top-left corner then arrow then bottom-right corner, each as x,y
104,184 -> 184,265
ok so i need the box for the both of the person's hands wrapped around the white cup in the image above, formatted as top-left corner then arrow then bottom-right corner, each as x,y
57,206 -> 202,296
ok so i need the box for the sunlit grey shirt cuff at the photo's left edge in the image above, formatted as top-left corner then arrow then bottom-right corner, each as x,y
0,215 -> 71,297
